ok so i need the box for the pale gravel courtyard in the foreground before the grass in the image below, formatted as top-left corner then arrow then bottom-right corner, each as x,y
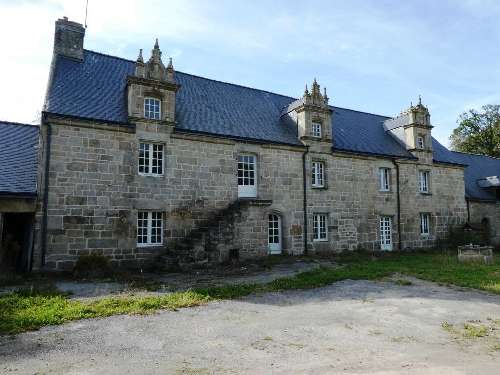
0,279 -> 500,375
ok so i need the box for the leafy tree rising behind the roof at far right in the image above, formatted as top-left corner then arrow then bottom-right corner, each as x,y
450,104 -> 500,158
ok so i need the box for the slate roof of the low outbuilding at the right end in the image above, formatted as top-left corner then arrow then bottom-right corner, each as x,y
450,151 -> 500,201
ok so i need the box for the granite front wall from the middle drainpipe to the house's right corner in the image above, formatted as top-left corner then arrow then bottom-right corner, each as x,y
307,147 -> 467,252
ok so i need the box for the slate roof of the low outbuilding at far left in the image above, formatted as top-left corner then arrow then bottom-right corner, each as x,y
0,121 -> 39,196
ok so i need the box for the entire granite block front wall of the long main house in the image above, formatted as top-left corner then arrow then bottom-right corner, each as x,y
35,119 -> 466,269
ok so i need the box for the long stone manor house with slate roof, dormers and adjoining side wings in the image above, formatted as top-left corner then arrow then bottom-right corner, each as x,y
0,18 -> 500,270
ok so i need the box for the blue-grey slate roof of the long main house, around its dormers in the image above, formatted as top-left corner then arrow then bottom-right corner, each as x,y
44,50 -> 498,201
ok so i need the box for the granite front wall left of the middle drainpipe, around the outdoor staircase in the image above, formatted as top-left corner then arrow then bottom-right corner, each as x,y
35,120 -> 303,269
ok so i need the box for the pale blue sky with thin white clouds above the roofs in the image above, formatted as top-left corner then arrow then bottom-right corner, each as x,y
0,0 -> 500,145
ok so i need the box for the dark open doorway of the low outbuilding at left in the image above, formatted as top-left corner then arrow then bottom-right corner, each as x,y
0,213 -> 33,272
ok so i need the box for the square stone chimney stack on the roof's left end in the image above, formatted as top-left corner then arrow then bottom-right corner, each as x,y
54,17 -> 85,61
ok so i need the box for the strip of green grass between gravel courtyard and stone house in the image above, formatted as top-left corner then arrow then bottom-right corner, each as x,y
0,253 -> 500,334
